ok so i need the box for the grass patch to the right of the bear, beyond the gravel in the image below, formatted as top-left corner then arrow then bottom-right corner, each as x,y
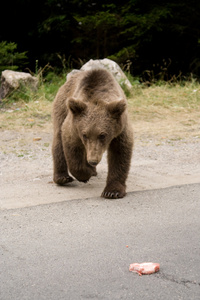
128,81 -> 200,119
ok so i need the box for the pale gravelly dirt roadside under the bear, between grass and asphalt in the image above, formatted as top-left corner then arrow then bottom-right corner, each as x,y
0,116 -> 200,210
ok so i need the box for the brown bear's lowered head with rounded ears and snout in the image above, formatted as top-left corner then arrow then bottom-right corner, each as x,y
68,98 -> 126,166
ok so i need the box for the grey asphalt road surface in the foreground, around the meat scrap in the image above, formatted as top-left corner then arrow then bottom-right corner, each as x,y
0,184 -> 200,300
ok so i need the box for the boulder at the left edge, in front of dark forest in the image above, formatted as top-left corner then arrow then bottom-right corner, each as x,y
0,70 -> 38,99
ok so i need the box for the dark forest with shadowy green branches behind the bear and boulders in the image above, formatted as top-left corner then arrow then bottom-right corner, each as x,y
0,0 -> 200,80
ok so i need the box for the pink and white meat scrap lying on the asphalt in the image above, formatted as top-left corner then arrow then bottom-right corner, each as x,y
129,262 -> 160,276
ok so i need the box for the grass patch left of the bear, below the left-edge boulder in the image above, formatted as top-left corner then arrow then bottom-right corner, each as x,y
0,73 -> 66,130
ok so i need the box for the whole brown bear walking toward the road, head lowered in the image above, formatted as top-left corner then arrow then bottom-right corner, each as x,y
52,69 -> 133,198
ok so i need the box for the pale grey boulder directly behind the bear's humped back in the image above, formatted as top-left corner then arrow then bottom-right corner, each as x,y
67,58 -> 132,88
